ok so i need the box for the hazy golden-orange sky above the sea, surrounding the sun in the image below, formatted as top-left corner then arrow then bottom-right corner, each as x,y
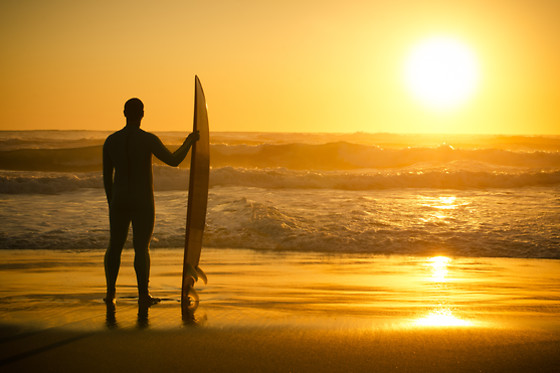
0,0 -> 560,134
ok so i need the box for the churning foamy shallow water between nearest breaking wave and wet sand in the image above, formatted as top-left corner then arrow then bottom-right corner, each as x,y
0,187 -> 560,258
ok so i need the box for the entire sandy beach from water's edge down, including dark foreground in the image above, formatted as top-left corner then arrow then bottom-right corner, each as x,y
0,249 -> 560,372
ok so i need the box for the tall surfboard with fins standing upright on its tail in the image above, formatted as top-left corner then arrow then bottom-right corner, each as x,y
181,76 -> 210,315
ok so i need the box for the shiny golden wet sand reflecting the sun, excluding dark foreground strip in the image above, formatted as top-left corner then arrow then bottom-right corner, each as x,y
0,248 -> 560,331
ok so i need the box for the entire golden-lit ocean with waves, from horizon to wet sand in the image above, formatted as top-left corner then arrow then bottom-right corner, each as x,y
0,131 -> 560,259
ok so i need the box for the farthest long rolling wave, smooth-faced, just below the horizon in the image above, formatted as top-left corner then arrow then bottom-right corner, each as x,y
0,142 -> 560,172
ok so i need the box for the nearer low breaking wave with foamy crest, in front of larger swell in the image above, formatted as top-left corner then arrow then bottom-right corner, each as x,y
0,166 -> 560,194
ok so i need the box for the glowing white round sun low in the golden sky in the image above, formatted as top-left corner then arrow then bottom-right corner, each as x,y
404,37 -> 480,111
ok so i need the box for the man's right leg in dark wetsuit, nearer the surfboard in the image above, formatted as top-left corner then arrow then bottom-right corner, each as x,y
132,207 -> 160,305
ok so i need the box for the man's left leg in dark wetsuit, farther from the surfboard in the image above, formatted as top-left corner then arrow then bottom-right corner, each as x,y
105,208 -> 130,303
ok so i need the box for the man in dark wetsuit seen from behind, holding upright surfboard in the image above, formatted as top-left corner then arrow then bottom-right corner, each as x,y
103,98 -> 199,306
